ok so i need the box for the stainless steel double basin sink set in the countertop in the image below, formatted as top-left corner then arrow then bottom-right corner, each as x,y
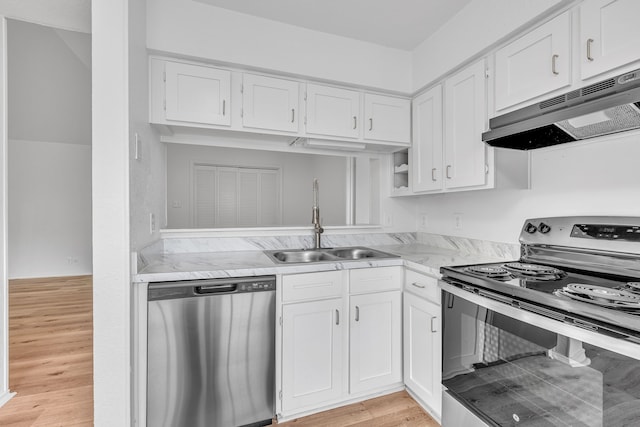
265,246 -> 398,264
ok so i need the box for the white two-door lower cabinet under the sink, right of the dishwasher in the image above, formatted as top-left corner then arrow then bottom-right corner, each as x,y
276,266 -> 403,419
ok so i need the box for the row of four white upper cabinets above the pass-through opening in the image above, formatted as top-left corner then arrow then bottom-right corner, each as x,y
149,57 -> 411,152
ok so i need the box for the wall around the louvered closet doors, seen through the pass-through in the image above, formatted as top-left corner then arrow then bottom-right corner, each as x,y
167,144 -> 347,228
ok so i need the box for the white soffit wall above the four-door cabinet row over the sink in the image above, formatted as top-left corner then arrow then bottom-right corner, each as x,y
147,0 -> 412,93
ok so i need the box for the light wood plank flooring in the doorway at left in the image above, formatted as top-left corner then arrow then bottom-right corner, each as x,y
0,276 -> 93,427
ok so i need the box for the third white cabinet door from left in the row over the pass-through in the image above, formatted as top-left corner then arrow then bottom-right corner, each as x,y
307,84 -> 361,138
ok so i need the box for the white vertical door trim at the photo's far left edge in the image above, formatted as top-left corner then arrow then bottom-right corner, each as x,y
0,16 -> 11,406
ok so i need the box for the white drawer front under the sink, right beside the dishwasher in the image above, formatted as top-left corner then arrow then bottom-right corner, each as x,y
282,271 -> 342,302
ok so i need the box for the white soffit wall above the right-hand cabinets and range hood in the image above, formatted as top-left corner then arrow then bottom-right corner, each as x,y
412,0 -> 572,91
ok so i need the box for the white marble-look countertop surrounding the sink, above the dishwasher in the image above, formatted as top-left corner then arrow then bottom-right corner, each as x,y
133,243 -> 504,283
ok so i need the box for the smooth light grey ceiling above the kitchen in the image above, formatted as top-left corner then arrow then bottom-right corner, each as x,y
196,0 -> 471,50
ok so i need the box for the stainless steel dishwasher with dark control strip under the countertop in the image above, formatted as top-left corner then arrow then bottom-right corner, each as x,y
147,276 -> 276,427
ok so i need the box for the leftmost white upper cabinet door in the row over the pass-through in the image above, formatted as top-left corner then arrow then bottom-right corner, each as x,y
165,62 -> 231,126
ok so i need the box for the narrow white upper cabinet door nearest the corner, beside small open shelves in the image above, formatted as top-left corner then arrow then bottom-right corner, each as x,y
411,85 -> 443,192
